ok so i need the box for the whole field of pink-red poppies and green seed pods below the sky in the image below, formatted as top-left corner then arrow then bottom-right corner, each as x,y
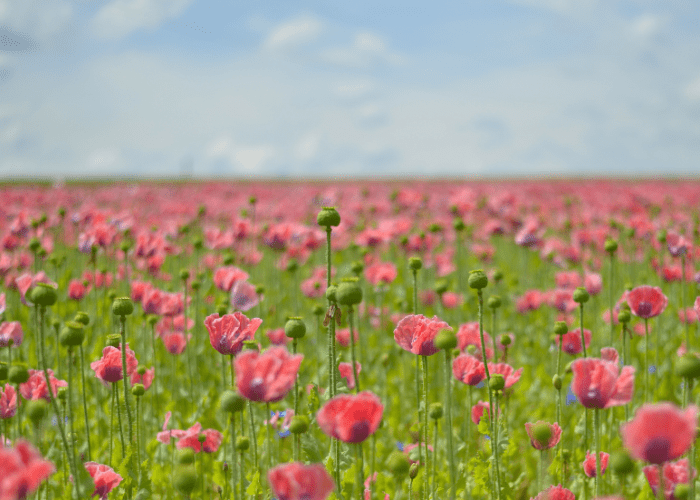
0,180 -> 700,500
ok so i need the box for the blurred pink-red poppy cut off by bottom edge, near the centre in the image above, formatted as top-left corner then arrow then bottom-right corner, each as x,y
267,462 -> 335,500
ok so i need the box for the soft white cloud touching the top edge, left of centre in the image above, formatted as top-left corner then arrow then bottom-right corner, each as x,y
92,0 -> 192,38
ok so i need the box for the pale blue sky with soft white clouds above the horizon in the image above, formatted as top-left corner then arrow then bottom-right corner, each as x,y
0,0 -> 700,178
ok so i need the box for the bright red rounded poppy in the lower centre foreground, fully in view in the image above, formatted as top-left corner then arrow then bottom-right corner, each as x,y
316,391 -> 384,443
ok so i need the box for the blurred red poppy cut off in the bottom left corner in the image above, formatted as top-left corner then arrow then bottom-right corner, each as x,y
0,439 -> 56,500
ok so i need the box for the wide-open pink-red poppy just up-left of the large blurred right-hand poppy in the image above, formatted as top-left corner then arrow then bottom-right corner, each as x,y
571,358 -> 635,409
